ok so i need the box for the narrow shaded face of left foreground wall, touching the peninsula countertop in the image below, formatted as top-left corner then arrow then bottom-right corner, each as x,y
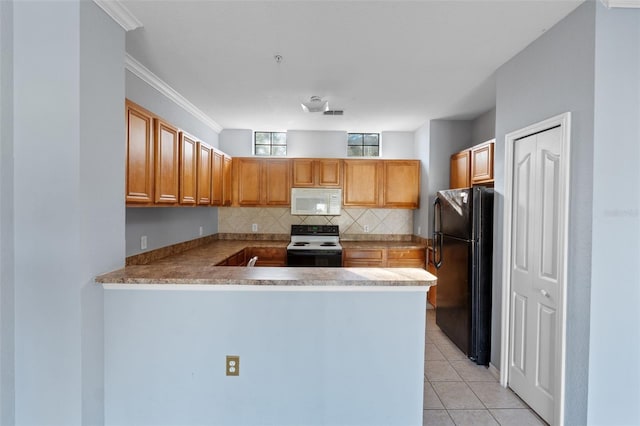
79,1 -> 125,425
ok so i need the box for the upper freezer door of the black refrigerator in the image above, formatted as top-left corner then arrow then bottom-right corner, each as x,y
437,188 -> 473,240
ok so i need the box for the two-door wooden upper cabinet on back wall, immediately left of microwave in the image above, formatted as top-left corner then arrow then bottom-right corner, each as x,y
233,158 -> 291,206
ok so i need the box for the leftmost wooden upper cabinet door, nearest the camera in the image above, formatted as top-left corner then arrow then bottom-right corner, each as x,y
125,102 -> 153,203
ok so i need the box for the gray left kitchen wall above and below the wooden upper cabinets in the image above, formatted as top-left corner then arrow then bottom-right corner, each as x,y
126,71 -> 220,256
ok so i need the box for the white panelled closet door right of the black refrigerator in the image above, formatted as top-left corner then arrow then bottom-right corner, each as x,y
509,127 -> 562,422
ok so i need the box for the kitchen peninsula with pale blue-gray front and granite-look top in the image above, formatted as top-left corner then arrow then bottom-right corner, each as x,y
96,240 -> 435,425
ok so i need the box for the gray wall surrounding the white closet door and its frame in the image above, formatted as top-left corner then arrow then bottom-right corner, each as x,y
491,2 -> 595,425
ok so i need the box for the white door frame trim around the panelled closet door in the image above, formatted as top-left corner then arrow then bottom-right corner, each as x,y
500,112 -> 571,426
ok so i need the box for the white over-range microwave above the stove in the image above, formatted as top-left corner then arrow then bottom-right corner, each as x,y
291,188 -> 342,216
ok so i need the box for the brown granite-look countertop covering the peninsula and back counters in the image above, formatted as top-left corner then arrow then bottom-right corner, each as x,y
96,240 -> 436,288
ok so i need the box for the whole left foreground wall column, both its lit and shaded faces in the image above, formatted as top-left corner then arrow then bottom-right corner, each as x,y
11,2 -> 124,425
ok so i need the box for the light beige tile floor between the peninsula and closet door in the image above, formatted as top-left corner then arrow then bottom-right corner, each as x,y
423,309 -> 546,426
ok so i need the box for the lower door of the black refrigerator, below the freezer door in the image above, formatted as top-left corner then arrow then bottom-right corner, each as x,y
436,235 -> 472,355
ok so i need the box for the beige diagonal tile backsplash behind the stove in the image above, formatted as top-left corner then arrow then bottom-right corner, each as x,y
218,207 -> 413,237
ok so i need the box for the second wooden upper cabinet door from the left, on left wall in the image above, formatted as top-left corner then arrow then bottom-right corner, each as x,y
154,118 -> 179,204
